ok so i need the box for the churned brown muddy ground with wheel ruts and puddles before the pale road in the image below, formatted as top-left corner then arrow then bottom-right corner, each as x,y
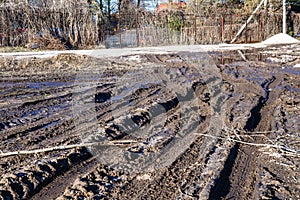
0,45 -> 300,199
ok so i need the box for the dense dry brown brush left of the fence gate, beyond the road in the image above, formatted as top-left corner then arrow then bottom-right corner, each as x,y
0,1 -> 98,49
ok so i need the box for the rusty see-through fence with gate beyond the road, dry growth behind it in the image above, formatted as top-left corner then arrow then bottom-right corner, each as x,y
104,11 -> 300,48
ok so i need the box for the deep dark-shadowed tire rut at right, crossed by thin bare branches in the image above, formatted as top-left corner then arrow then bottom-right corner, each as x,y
209,76 -> 276,199
